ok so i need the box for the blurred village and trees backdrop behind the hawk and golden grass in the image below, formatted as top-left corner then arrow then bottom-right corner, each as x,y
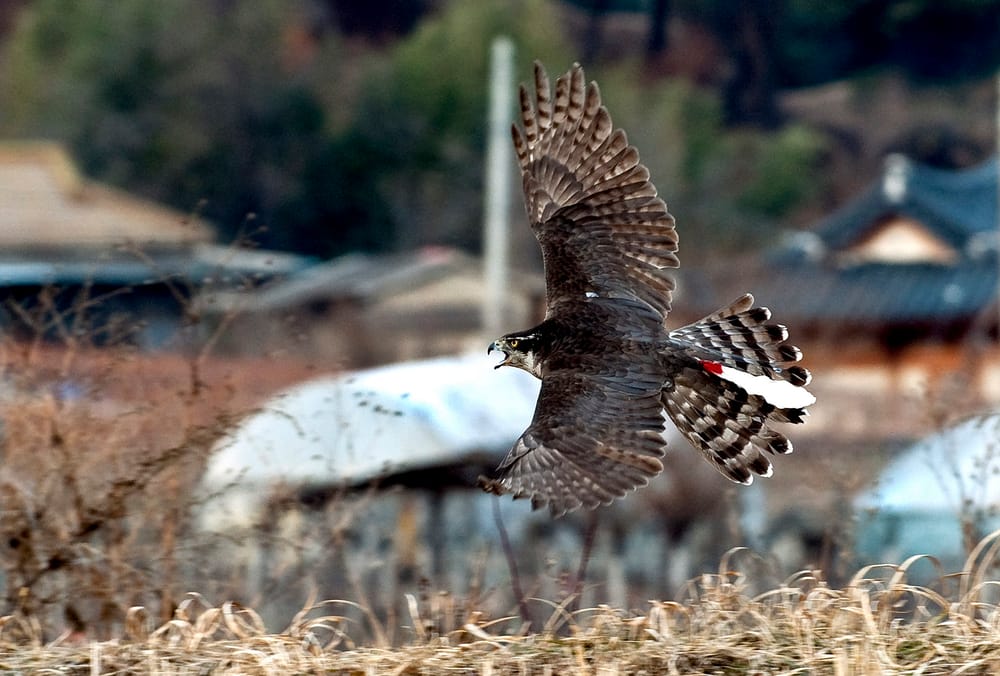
0,0 -> 1000,636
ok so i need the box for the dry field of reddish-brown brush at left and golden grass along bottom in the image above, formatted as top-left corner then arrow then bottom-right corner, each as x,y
0,332 -> 1000,675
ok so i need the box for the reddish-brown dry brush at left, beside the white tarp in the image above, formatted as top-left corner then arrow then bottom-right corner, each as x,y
0,274 -> 320,638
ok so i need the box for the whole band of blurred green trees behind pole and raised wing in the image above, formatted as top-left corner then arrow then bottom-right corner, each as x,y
0,0 -> 818,256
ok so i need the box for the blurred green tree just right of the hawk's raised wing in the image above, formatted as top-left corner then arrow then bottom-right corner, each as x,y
588,64 -> 826,262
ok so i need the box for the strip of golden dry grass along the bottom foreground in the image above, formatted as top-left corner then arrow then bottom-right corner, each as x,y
0,532 -> 1000,675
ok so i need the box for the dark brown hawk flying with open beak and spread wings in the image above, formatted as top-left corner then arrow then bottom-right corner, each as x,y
481,62 -> 815,516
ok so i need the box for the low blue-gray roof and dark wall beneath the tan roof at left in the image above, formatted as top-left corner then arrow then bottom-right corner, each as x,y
0,243 -> 314,348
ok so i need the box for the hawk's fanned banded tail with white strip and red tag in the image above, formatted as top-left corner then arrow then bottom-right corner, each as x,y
661,294 -> 816,484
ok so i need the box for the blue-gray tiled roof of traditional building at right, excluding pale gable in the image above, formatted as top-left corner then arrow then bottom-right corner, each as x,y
756,155 -> 1000,338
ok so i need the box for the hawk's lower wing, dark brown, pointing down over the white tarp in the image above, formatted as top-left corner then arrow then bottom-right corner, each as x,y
490,357 -> 664,516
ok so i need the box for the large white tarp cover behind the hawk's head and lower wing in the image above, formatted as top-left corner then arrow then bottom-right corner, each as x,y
203,350 -> 539,490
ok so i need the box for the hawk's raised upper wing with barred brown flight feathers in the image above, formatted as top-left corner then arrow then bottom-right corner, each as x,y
513,62 -> 678,316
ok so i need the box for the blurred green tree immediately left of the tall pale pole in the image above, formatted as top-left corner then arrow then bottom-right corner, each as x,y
351,0 -> 572,249
